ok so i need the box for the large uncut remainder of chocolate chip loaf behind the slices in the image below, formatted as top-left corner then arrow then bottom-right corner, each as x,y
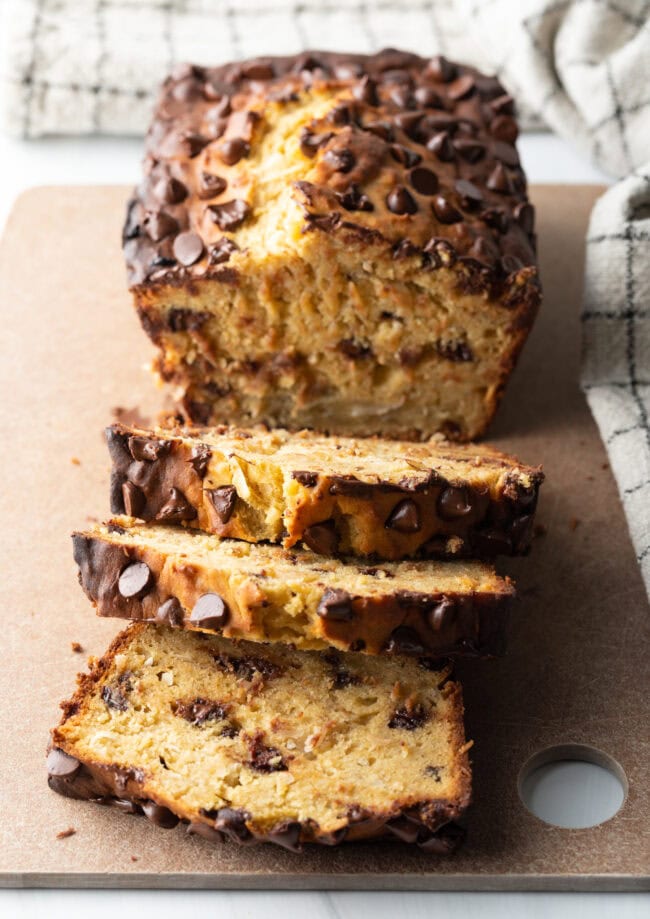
124,50 -> 540,440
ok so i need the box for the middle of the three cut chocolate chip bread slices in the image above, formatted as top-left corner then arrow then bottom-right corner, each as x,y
73,517 -> 514,656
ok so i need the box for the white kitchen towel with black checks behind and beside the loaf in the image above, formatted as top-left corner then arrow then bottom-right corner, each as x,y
1,0 -> 650,593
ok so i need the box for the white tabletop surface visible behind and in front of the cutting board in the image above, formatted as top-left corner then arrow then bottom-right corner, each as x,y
0,127 -> 650,919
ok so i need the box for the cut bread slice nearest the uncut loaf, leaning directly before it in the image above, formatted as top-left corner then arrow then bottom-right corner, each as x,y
106,424 -> 543,559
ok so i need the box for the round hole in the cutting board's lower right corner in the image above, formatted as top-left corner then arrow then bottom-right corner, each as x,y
518,744 -> 628,829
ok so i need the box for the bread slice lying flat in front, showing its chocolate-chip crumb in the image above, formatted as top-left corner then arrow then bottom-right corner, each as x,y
48,623 -> 470,852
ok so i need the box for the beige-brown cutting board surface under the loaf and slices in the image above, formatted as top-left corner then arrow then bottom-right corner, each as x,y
0,186 -> 650,890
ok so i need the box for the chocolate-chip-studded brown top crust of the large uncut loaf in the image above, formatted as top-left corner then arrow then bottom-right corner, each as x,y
124,49 -> 538,305
